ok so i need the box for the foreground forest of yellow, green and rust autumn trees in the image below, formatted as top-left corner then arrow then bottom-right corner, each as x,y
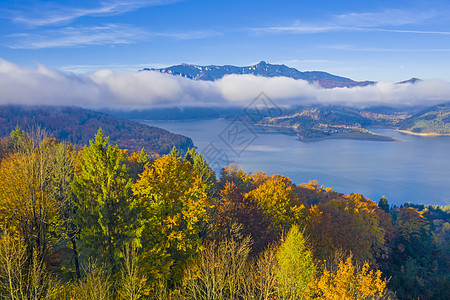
0,127 -> 450,300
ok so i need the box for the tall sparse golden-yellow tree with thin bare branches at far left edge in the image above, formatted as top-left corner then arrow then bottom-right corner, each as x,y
0,128 -> 71,296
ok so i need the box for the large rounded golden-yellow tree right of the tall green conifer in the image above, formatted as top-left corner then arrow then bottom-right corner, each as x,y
133,155 -> 209,283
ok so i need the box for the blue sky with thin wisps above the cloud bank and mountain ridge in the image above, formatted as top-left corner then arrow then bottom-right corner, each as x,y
0,0 -> 450,81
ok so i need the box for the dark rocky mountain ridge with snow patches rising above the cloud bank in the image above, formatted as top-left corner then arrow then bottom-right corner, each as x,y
141,61 -> 375,88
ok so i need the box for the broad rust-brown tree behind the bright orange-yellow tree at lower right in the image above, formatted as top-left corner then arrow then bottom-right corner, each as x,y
306,194 -> 387,262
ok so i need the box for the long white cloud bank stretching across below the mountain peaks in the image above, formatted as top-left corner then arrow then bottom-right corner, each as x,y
0,59 -> 450,109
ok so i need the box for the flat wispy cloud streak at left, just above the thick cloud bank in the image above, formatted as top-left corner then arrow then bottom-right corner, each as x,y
8,24 -> 149,49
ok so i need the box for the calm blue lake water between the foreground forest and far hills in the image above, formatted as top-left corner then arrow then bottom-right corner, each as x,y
141,119 -> 450,205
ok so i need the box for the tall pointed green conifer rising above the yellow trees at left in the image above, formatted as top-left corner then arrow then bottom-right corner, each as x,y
72,129 -> 136,273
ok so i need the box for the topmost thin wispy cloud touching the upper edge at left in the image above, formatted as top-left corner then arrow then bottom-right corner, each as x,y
10,0 -> 183,26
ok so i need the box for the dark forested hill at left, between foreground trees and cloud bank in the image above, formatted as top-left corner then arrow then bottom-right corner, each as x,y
0,105 -> 193,154
